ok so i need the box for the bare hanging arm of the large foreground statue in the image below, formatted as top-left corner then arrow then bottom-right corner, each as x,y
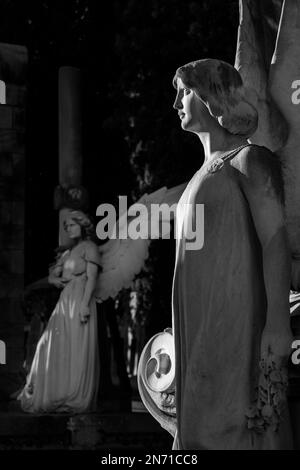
236,147 -> 291,356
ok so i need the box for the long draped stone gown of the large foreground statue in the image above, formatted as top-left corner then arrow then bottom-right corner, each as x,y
173,146 -> 291,449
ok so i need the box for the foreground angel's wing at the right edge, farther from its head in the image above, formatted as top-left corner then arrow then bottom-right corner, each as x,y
268,0 -> 300,259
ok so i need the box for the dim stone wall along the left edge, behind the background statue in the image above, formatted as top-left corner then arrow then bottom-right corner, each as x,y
0,44 -> 27,401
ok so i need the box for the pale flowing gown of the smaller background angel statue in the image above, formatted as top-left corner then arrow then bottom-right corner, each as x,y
18,241 -> 100,412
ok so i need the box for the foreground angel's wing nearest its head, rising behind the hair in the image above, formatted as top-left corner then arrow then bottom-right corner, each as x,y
235,0 -> 286,151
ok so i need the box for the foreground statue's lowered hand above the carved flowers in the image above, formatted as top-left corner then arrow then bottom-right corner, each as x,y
261,326 -> 293,363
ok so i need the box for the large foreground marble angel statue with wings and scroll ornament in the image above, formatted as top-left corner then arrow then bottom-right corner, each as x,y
138,0 -> 300,449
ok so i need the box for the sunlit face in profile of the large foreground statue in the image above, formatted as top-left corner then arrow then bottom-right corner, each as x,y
173,78 -> 216,133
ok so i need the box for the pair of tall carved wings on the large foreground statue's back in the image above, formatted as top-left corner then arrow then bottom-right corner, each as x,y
235,0 -> 300,289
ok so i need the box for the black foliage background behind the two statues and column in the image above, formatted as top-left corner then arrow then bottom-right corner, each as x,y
0,0 -> 238,335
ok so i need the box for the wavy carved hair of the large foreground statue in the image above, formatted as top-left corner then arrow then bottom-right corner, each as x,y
173,59 -> 258,137
